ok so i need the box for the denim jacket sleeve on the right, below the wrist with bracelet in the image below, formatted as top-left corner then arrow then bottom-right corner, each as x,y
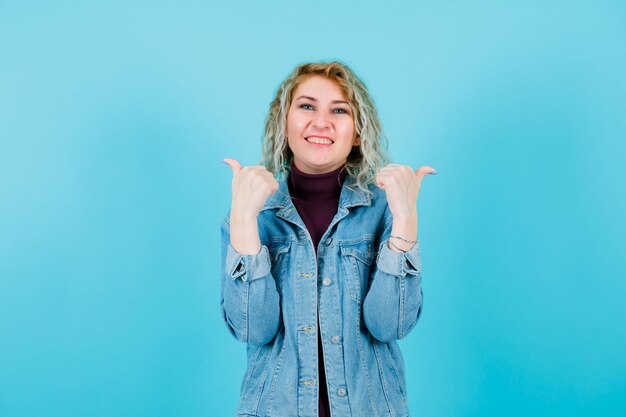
363,211 -> 422,342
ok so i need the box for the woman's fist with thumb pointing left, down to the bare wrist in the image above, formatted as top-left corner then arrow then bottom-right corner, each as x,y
224,158 -> 278,218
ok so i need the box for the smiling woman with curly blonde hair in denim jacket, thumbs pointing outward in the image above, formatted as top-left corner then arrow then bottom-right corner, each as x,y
221,62 -> 436,417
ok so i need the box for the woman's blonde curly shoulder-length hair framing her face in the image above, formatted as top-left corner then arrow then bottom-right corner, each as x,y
261,61 -> 389,193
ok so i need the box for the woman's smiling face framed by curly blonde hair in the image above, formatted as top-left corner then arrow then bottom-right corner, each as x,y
287,76 -> 360,174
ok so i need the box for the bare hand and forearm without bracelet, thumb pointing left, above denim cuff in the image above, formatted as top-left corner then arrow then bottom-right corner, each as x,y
224,158 -> 278,255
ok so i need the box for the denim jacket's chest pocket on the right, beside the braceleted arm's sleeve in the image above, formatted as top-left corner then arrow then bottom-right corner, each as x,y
341,241 -> 374,304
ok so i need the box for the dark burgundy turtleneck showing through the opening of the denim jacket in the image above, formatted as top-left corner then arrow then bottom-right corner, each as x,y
288,162 -> 347,417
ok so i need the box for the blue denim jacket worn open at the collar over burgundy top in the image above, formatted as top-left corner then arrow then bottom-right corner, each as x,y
221,177 -> 422,417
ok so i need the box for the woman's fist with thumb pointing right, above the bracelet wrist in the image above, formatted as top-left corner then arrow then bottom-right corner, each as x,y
376,164 -> 437,217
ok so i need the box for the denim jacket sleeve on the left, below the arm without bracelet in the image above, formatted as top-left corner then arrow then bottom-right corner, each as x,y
220,218 -> 280,345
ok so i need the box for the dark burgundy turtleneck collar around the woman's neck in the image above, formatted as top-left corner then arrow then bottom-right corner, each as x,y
289,161 -> 348,206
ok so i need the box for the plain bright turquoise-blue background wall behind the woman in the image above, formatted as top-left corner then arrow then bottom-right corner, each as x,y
0,1 -> 626,417
